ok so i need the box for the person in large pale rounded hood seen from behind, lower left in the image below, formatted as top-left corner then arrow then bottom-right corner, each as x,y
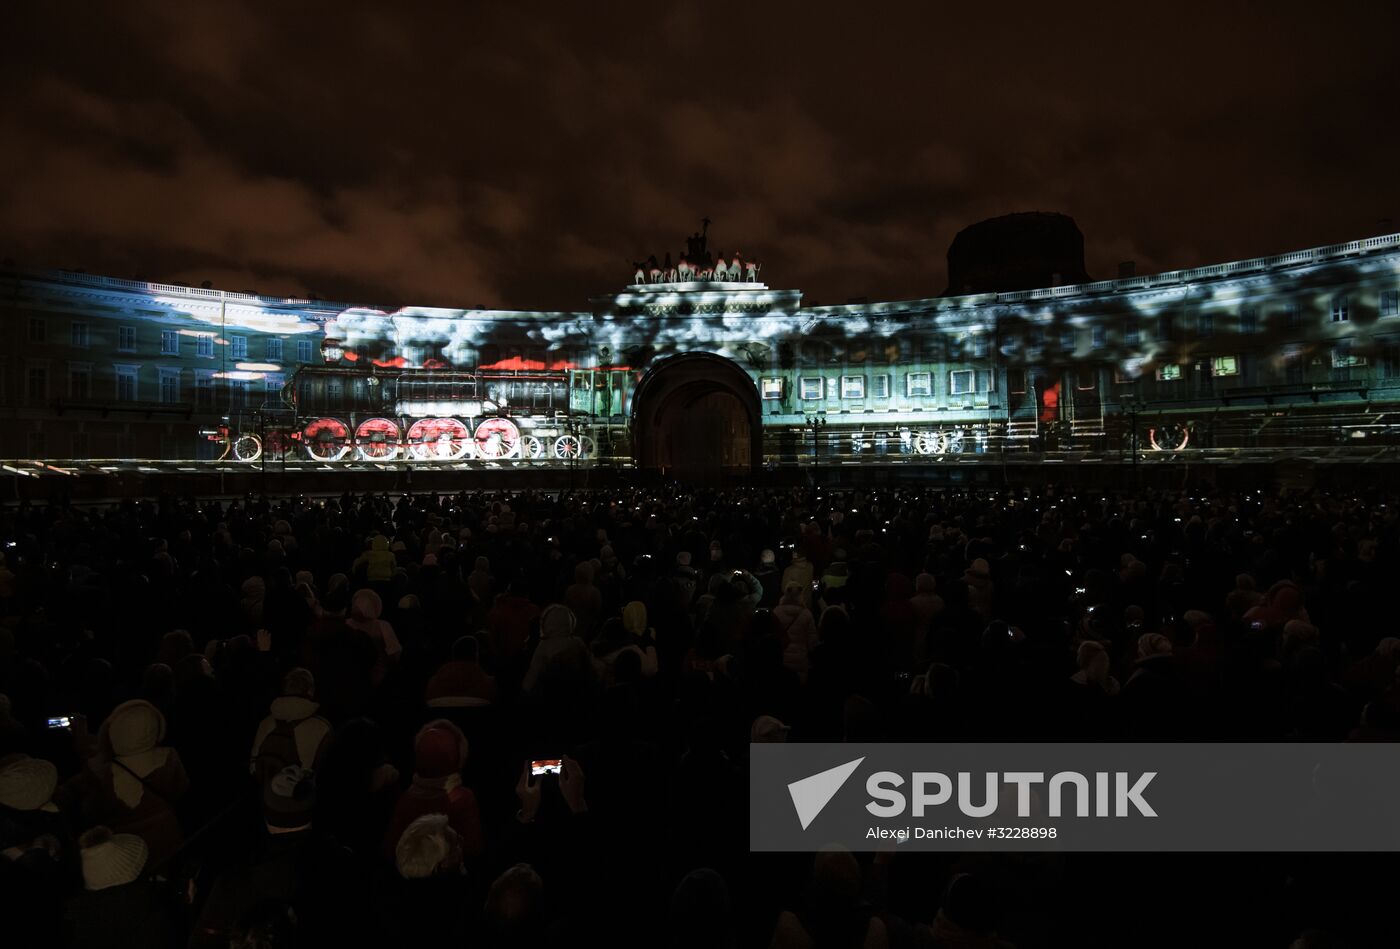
70,698 -> 189,866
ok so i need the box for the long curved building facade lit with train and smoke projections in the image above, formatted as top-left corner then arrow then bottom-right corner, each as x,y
0,219 -> 1400,473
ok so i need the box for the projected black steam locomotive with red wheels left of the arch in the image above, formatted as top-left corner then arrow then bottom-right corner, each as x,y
220,367 -> 629,465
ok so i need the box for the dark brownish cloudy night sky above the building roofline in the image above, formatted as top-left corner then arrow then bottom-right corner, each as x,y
0,0 -> 1400,309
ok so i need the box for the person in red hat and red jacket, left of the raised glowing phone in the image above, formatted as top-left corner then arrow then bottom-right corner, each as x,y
384,718 -> 482,859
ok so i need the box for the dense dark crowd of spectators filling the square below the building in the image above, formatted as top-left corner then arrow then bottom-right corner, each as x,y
0,487 -> 1400,949
